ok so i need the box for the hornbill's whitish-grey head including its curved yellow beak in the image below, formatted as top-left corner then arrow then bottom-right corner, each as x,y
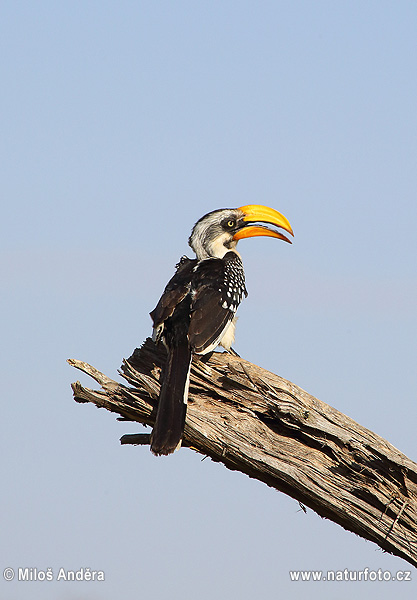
188,204 -> 294,260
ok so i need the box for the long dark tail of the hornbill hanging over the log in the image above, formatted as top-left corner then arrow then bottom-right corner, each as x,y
151,342 -> 191,456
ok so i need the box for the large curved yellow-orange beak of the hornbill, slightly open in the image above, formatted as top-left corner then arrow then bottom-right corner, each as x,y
233,204 -> 294,244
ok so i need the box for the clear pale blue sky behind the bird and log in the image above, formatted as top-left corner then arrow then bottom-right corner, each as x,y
0,0 -> 417,600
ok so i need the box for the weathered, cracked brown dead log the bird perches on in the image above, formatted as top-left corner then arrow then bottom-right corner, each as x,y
69,339 -> 417,566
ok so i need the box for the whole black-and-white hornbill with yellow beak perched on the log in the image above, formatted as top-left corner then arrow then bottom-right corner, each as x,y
150,204 -> 293,455
